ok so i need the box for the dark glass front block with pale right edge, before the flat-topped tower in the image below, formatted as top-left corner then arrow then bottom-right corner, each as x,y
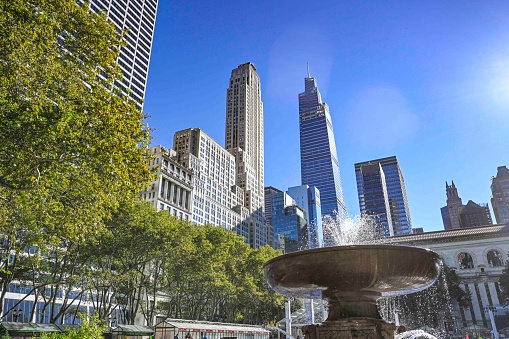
357,162 -> 394,236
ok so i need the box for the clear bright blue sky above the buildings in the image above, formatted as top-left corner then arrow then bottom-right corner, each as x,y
144,0 -> 509,231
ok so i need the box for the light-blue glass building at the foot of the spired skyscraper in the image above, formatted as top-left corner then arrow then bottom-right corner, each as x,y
286,185 -> 323,249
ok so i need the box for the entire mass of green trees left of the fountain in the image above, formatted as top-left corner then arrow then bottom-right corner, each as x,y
0,0 -> 284,330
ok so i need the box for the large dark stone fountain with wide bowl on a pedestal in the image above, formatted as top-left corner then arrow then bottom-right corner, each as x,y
263,245 -> 441,339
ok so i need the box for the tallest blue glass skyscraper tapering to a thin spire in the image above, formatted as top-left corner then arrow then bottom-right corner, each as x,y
299,70 -> 346,231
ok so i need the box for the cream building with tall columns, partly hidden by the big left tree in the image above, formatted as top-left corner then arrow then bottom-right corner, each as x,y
140,145 -> 194,220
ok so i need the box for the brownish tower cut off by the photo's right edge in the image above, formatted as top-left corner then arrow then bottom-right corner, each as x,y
491,166 -> 509,224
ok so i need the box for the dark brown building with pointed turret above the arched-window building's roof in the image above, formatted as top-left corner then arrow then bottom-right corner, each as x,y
440,181 -> 493,230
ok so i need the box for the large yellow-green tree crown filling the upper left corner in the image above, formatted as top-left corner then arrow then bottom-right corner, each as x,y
0,0 -> 150,243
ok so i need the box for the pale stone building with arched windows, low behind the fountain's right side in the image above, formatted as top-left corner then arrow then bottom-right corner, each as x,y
390,224 -> 509,338
